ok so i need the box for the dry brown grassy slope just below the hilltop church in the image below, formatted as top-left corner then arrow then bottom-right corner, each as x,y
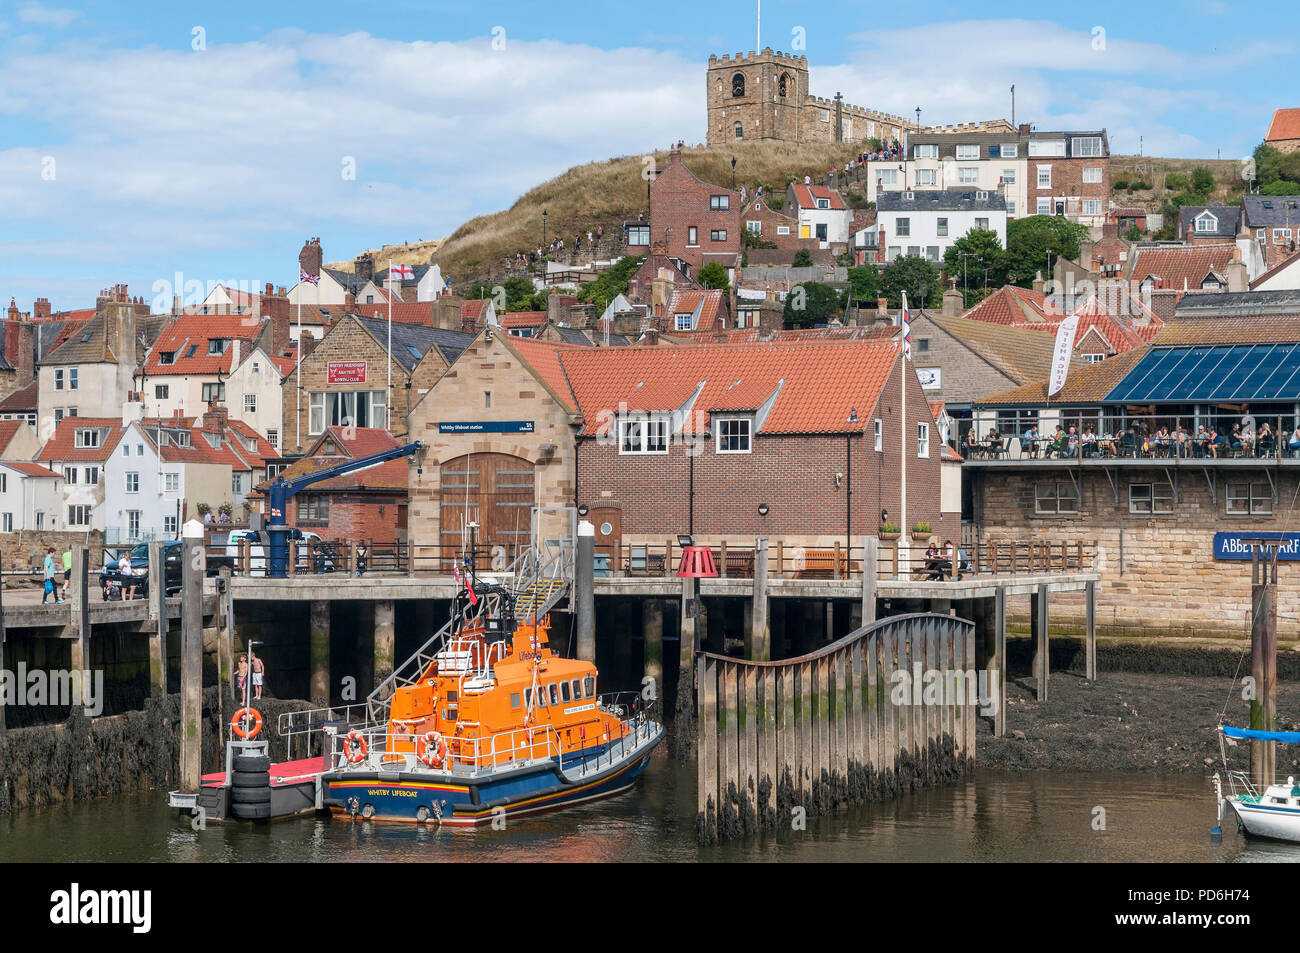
433,142 -> 861,282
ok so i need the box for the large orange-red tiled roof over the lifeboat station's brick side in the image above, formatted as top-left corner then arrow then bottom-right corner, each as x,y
558,338 -> 900,434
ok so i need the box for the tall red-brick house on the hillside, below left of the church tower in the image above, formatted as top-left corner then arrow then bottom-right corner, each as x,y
650,143 -> 741,281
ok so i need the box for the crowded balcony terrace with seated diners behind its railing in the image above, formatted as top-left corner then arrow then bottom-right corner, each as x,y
958,412 -> 1300,463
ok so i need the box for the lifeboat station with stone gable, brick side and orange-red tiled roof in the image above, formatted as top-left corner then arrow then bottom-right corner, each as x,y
408,333 -> 961,572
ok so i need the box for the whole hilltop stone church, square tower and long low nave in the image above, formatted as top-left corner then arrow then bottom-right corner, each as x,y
707,47 -> 917,146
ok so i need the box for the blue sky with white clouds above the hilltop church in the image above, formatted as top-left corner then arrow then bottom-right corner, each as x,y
0,0 -> 1284,311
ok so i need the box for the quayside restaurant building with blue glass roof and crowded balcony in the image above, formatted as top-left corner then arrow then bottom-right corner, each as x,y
963,315 -> 1300,638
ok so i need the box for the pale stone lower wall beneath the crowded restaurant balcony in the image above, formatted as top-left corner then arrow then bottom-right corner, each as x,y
966,467 -> 1300,637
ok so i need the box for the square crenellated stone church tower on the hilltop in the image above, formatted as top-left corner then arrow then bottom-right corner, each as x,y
706,47 -> 809,146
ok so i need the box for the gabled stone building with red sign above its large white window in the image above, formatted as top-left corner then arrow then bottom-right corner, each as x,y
281,313 -> 473,451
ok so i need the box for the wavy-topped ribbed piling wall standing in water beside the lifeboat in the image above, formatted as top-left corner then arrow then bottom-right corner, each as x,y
696,614 -> 978,844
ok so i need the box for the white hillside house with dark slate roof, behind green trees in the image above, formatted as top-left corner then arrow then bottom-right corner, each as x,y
876,190 -> 1006,261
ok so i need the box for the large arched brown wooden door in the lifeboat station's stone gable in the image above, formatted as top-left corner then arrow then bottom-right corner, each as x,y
439,454 -> 536,569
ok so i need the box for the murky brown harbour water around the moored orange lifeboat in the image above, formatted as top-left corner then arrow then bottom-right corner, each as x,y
0,750 -> 1300,863
